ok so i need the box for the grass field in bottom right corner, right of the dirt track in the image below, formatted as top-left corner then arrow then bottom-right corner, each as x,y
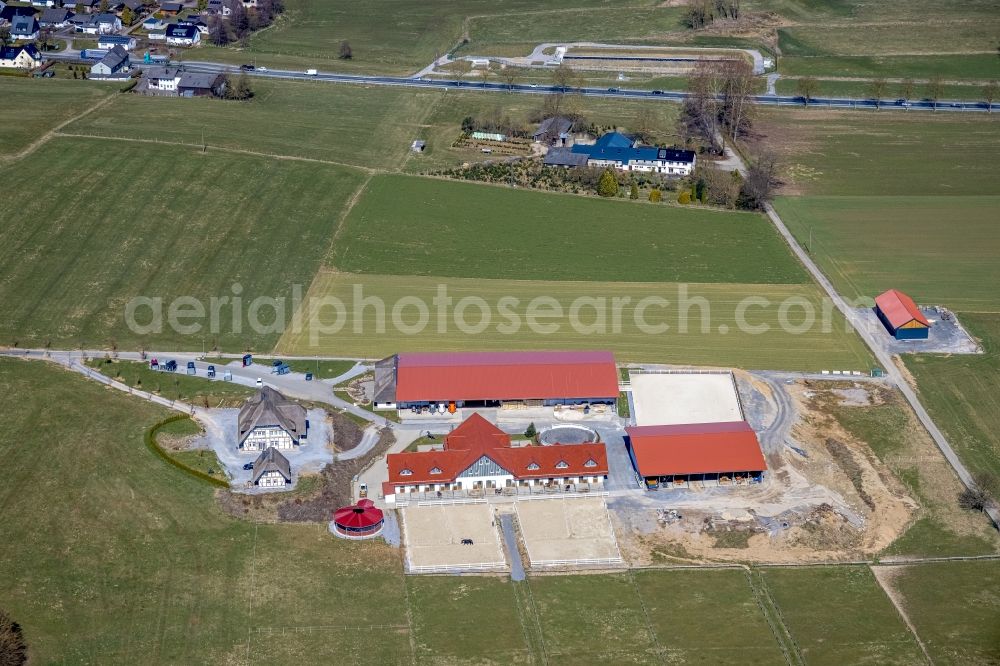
893,561 -> 1000,666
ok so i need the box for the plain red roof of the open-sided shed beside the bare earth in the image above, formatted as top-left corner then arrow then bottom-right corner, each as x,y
625,421 -> 767,476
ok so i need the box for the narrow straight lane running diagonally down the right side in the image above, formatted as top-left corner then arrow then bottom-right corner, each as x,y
726,147 -> 1000,528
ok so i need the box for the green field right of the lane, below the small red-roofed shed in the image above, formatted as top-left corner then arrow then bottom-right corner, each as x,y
904,312 -> 1000,486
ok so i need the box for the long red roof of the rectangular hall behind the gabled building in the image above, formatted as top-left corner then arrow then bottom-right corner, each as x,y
396,351 -> 618,402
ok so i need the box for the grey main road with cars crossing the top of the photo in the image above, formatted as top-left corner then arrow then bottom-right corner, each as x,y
33,53 -> 984,112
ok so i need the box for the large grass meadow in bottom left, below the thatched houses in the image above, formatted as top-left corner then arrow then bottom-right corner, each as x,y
0,360 -> 409,664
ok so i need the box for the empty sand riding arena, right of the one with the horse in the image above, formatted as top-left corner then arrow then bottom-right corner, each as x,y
515,497 -> 622,567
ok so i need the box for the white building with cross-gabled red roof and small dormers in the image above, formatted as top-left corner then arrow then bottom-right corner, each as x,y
383,414 -> 608,502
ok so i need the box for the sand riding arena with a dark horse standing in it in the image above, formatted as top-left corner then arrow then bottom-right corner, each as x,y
400,502 -> 507,573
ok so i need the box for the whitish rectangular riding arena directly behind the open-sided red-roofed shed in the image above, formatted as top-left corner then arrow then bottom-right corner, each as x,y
629,371 -> 743,426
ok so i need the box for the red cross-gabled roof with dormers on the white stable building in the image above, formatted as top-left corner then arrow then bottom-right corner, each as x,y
386,414 -> 608,484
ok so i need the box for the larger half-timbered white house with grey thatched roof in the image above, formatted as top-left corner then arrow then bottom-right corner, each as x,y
236,386 -> 309,451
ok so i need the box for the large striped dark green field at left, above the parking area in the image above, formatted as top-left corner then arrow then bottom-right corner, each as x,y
0,138 -> 361,350
